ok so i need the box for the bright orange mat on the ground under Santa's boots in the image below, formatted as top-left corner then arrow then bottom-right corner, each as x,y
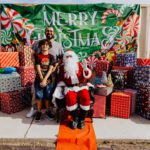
56,118 -> 97,150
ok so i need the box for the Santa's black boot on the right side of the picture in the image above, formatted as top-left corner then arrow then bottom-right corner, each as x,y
78,109 -> 88,129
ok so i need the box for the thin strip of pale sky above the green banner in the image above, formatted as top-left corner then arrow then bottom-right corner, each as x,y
0,0 -> 150,4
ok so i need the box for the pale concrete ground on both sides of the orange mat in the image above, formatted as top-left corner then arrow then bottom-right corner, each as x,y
0,109 -> 150,150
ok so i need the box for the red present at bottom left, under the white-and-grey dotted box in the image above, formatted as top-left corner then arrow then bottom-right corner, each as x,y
0,91 -> 23,114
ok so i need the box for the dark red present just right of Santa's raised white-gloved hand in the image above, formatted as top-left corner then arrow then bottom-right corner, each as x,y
95,60 -> 109,77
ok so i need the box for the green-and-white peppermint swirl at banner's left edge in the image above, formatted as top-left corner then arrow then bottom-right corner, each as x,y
1,30 -> 12,45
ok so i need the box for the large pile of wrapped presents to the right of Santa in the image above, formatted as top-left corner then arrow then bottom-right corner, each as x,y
91,53 -> 150,119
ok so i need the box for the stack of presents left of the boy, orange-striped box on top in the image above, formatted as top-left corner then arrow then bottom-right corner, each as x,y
0,46 -> 35,114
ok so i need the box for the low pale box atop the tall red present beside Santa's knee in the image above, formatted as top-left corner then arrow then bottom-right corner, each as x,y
95,87 -> 113,96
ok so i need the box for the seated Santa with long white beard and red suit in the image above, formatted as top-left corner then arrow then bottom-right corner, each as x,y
57,50 -> 92,129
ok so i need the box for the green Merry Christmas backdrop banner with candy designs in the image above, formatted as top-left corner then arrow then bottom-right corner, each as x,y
0,3 -> 140,63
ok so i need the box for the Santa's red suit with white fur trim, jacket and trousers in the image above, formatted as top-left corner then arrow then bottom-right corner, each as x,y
59,55 -> 92,111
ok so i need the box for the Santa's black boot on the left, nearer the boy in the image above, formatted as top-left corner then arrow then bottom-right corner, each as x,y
70,110 -> 78,129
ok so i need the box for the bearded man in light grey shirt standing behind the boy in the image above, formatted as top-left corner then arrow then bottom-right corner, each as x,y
26,26 -> 64,118
